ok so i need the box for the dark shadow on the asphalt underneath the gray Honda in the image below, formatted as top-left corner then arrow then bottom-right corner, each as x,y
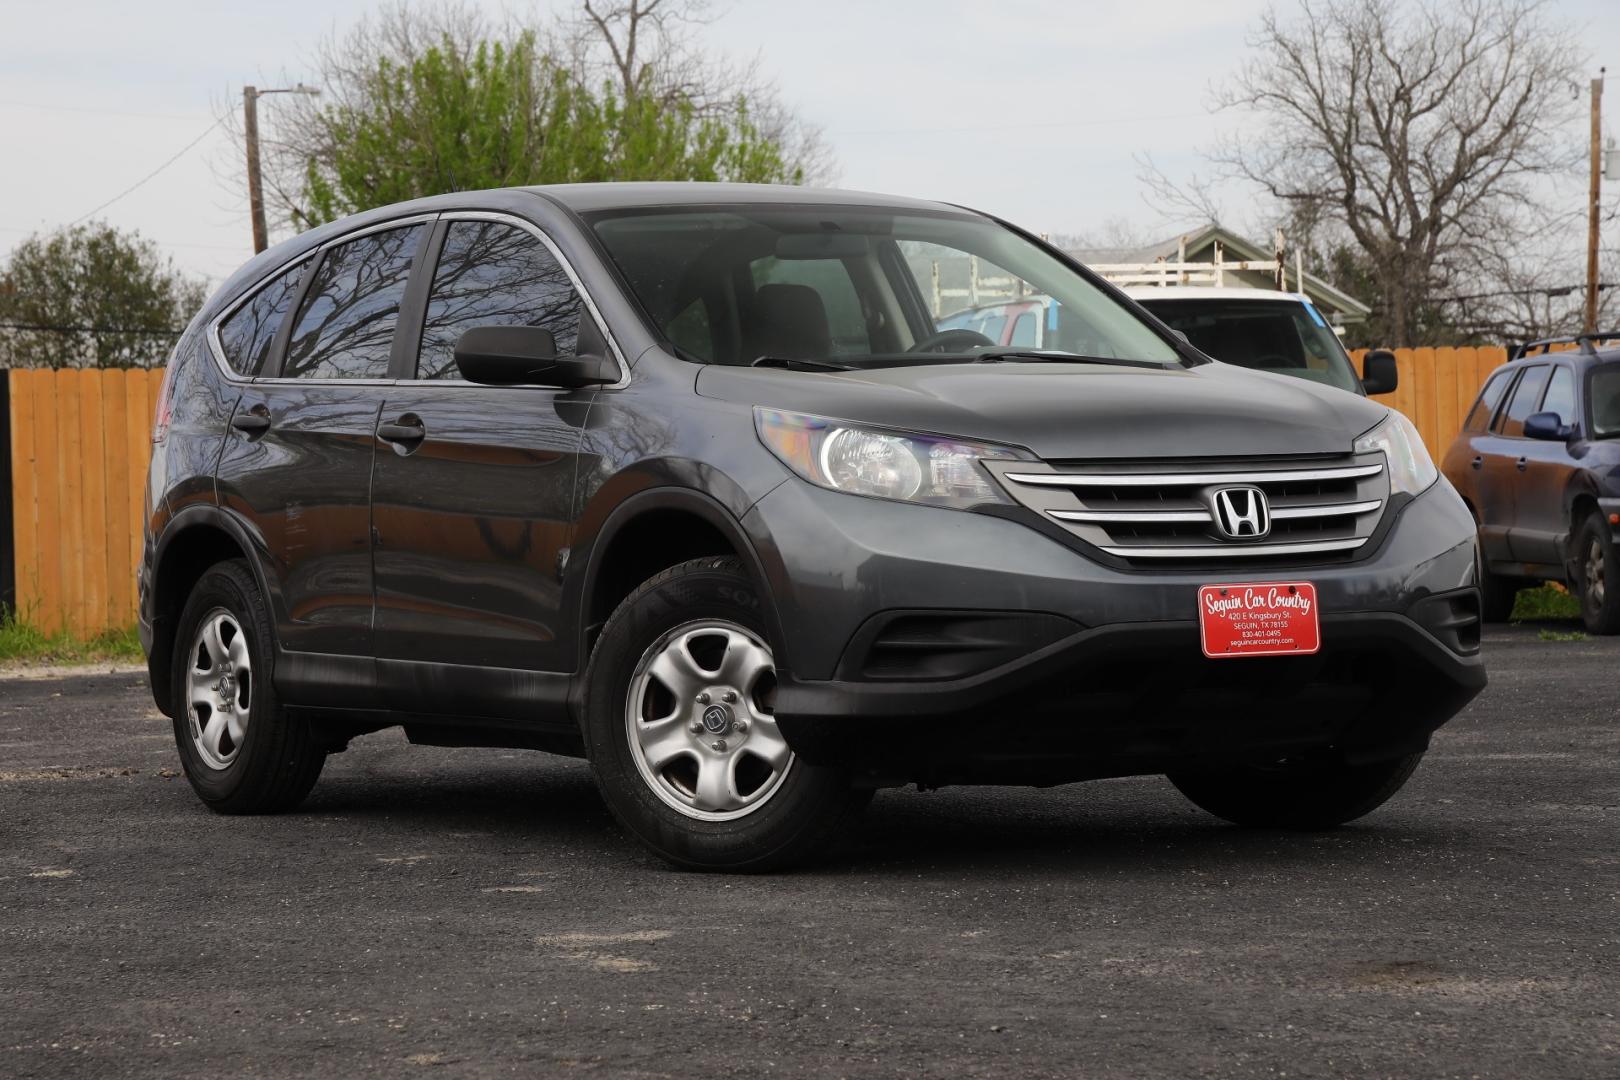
291,759 -> 1466,876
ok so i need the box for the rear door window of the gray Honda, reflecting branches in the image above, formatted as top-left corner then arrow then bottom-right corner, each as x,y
282,225 -> 423,379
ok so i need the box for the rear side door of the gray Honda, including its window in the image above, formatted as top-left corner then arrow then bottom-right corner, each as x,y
219,220 -> 429,676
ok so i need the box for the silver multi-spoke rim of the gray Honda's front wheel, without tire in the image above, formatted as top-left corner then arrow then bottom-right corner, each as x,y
625,620 -> 794,821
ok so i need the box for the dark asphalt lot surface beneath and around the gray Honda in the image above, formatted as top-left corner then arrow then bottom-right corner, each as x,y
0,627 -> 1620,1078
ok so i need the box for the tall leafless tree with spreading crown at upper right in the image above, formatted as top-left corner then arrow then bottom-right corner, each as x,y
1213,0 -> 1581,345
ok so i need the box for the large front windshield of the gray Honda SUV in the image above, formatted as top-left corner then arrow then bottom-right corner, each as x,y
591,206 -> 1181,368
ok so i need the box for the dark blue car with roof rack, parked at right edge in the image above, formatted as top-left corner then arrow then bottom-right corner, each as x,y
1442,334 -> 1620,633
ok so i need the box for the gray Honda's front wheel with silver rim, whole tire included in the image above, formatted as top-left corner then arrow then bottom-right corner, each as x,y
585,557 -> 872,871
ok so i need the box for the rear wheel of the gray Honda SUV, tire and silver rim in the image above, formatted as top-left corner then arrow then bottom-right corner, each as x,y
170,559 -> 326,814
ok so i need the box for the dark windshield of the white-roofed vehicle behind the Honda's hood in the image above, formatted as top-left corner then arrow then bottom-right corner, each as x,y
1139,298 -> 1361,393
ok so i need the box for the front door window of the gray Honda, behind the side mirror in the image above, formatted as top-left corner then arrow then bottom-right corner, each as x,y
416,222 -> 580,379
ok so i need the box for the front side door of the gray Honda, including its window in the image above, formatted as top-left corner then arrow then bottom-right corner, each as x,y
371,214 -> 604,717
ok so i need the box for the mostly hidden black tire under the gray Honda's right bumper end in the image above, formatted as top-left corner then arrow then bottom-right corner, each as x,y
1170,753 -> 1422,829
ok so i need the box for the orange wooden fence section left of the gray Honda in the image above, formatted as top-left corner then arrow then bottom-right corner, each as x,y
0,369 -> 164,636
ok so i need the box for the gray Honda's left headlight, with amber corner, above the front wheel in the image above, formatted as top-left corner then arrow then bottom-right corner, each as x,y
753,408 -> 1024,510
